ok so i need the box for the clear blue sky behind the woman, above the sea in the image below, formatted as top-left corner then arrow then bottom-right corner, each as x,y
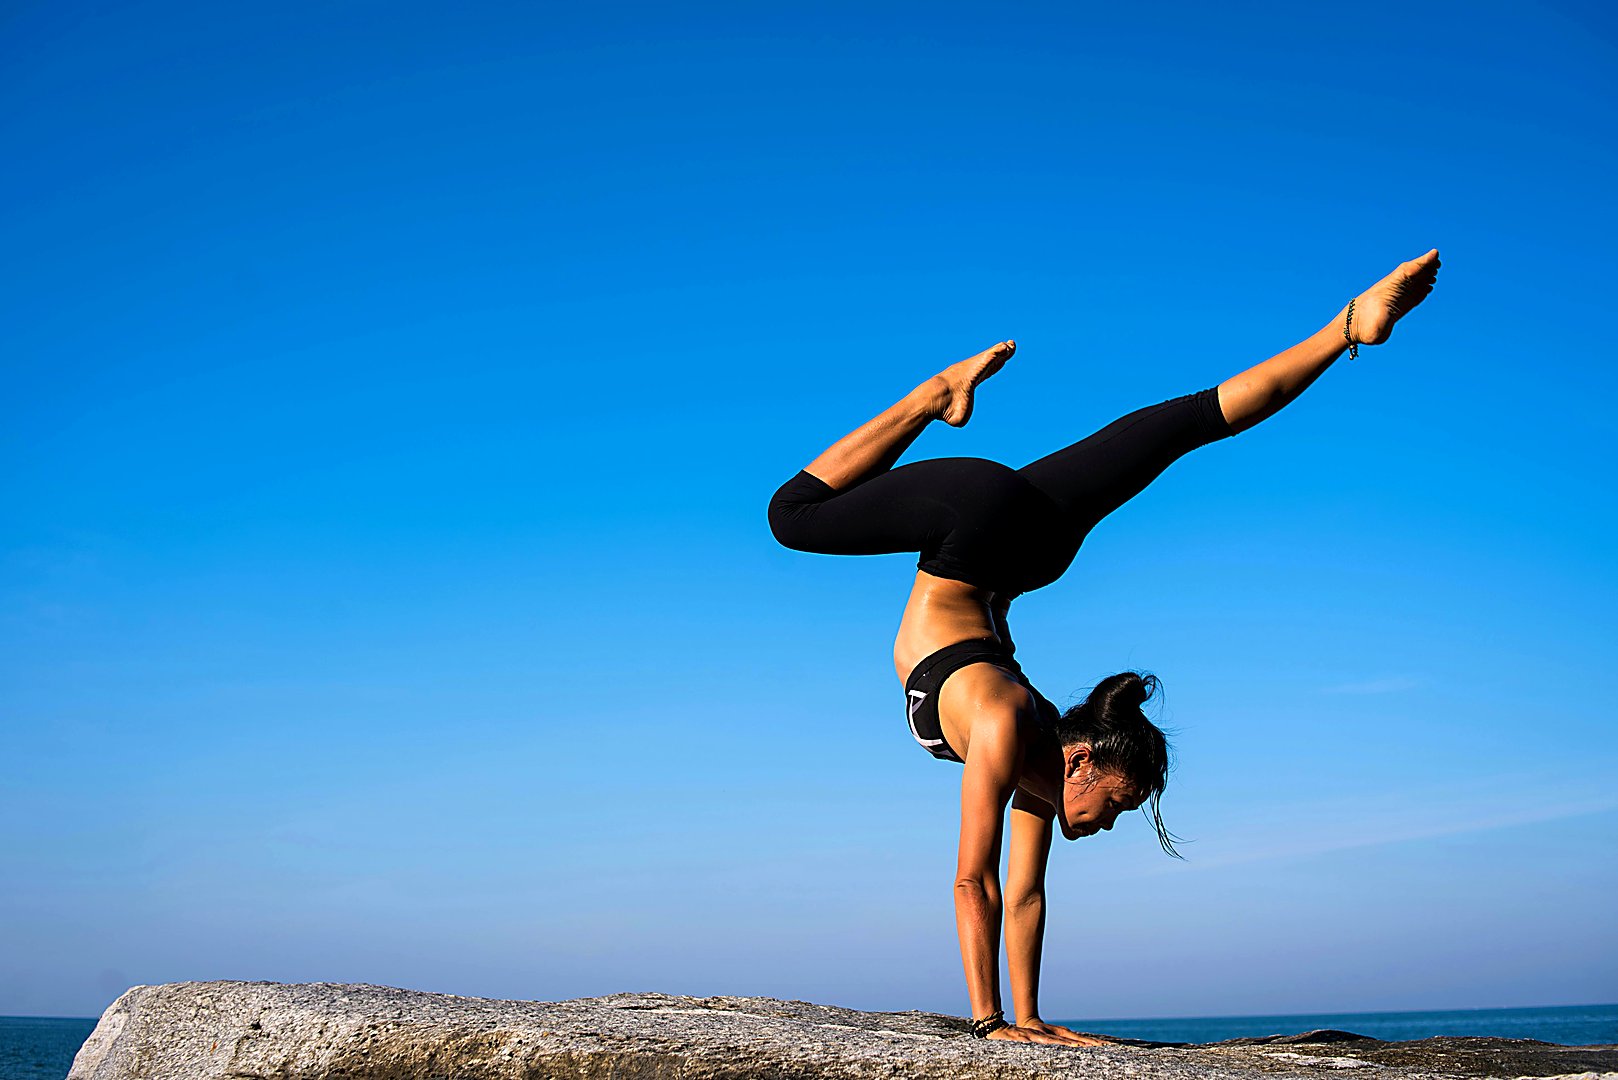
0,0 -> 1618,1017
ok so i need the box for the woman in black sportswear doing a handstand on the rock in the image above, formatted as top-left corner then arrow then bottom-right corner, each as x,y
770,249 -> 1438,1046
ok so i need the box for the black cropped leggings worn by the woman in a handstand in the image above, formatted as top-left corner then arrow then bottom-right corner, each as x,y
770,389 -> 1235,596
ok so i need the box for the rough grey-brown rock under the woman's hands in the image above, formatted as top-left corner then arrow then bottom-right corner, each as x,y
68,983 -> 1618,1080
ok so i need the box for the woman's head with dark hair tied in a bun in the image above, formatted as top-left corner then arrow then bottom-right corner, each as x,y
1055,672 -> 1180,858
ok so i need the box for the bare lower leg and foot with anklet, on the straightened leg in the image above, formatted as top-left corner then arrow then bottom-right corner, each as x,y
1218,248 -> 1440,432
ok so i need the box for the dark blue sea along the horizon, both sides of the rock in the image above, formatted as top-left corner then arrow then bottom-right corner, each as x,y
0,1006 -> 1618,1080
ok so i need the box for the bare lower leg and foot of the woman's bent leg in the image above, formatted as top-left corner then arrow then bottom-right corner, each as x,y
804,342 -> 1016,491
